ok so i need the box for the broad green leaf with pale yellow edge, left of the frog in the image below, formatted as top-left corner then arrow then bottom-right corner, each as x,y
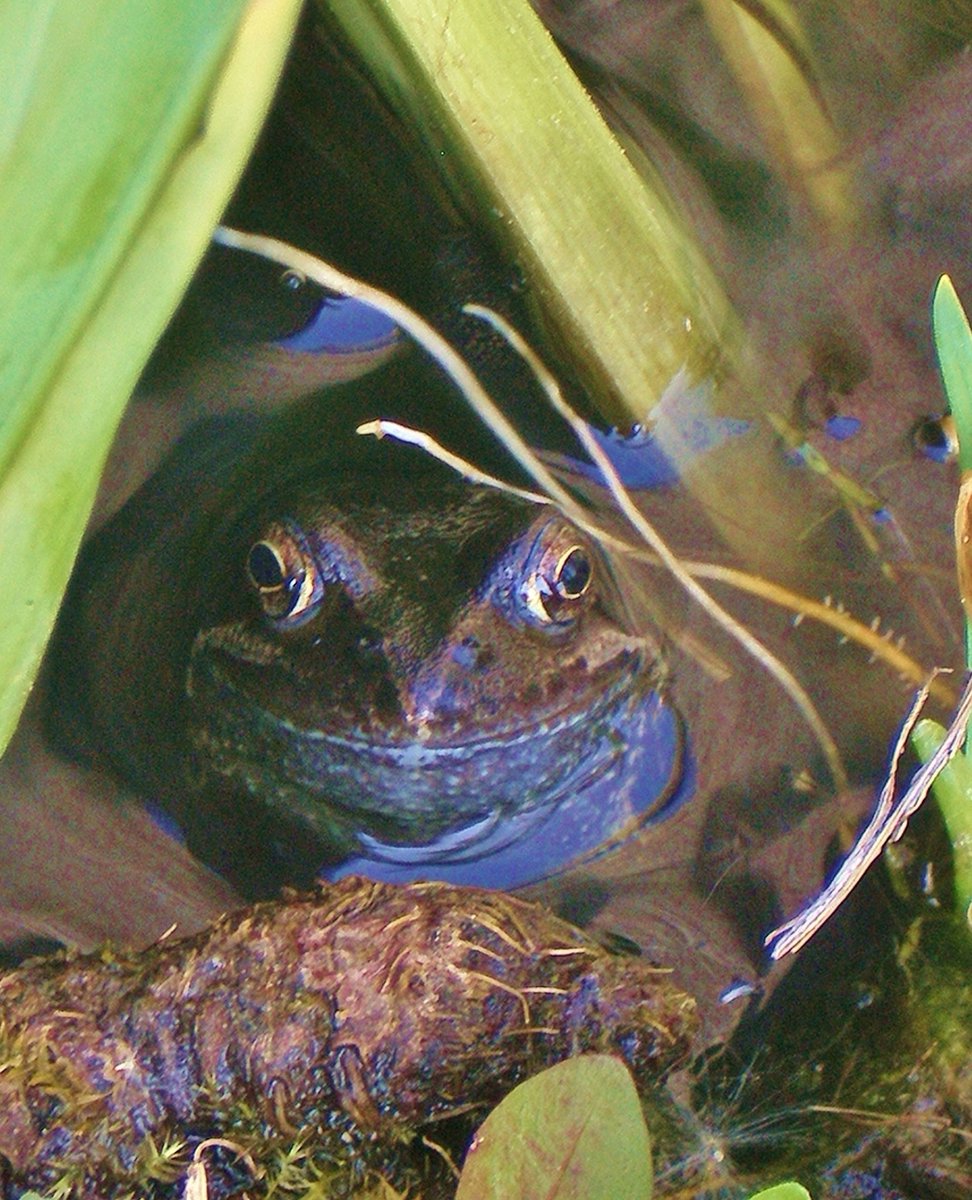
0,0 -> 300,748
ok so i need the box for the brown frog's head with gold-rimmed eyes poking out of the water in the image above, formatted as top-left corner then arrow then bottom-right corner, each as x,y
188,476 -> 672,860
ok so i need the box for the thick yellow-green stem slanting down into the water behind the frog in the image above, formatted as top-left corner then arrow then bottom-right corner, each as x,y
318,0 -> 733,424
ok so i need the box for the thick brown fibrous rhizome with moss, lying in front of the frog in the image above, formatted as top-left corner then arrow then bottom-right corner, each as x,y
0,878 -> 697,1198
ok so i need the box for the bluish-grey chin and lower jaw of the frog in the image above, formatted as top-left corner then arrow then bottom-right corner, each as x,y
191,654 -> 680,864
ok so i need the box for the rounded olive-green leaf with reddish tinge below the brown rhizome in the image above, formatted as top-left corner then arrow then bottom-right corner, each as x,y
456,1055 -> 652,1200
